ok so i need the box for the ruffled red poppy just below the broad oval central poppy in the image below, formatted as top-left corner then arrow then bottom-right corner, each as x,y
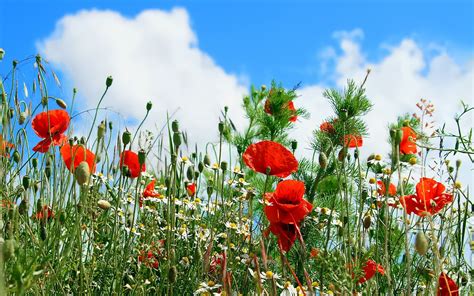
264,180 -> 313,224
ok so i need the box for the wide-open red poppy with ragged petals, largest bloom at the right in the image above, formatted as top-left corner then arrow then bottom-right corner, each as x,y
400,178 -> 453,217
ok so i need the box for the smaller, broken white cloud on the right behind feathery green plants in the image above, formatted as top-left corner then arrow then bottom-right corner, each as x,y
297,30 -> 474,153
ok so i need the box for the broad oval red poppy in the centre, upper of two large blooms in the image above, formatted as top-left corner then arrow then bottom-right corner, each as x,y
242,141 -> 298,178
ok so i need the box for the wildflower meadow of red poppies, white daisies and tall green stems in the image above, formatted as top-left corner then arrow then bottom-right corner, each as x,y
0,50 -> 474,296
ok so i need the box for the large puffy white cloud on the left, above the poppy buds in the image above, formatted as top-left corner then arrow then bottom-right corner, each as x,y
37,8 -> 247,147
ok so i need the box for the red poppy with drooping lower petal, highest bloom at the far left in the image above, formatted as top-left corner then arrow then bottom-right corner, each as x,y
31,110 -> 70,153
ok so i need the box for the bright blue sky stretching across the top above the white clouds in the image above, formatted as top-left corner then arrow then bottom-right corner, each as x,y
0,0 -> 474,85
